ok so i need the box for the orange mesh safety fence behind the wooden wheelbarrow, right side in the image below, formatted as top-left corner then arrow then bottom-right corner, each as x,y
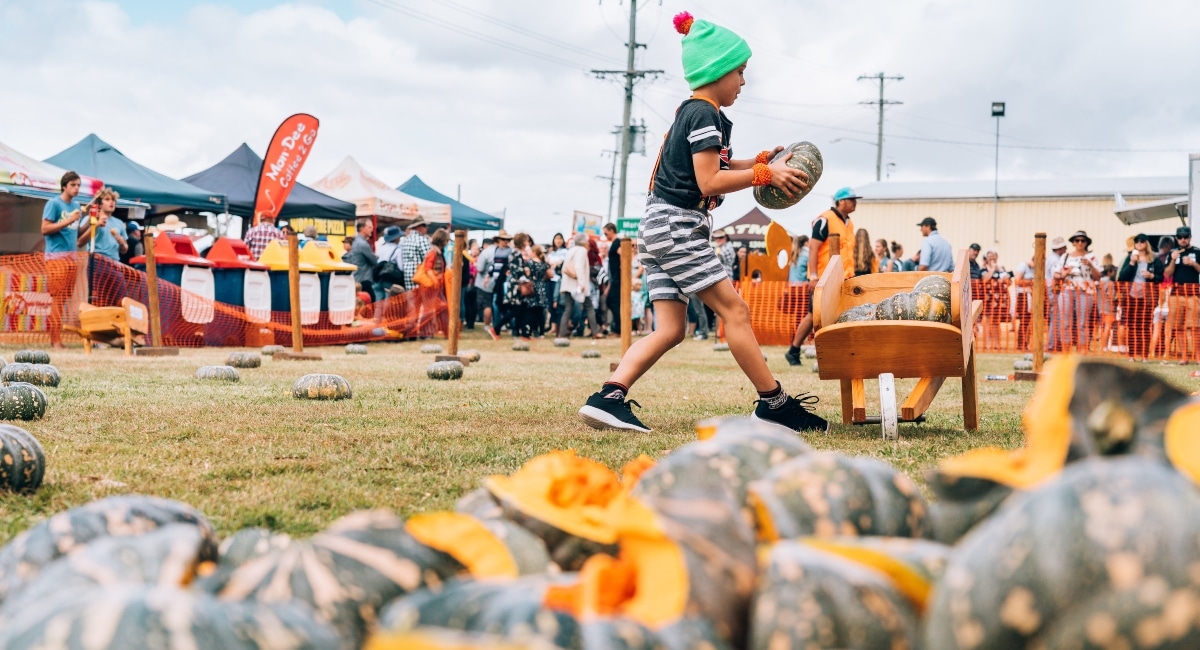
738,279 -> 1200,362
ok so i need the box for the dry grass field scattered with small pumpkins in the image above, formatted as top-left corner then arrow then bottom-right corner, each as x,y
0,333 -> 1196,551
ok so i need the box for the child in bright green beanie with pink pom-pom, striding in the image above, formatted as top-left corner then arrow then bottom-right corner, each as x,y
580,12 -> 829,432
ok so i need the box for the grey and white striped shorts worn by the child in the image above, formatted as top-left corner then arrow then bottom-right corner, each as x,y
637,194 -> 728,302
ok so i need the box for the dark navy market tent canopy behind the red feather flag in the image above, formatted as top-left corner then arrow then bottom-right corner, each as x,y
184,143 -> 354,221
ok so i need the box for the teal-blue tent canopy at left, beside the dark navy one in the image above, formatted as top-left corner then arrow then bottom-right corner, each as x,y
46,133 -> 226,213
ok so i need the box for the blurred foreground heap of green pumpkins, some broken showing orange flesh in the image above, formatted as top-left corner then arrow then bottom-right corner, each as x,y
0,357 -> 1200,650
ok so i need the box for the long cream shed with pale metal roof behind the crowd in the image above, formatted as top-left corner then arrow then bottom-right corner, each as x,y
852,176 -> 1188,271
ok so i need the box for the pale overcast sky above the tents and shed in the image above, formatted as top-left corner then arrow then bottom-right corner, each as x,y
0,0 -> 1200,240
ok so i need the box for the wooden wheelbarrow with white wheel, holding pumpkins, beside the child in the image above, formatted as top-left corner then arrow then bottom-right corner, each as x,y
812,251 -> 983,440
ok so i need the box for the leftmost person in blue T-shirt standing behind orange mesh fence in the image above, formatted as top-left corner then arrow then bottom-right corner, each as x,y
42,171 -> 84,348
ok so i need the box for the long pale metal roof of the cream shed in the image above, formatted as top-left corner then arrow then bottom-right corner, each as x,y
856,176 -> 1188,201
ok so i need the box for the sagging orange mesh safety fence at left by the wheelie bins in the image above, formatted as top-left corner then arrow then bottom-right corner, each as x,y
0,253 -> 446,348
